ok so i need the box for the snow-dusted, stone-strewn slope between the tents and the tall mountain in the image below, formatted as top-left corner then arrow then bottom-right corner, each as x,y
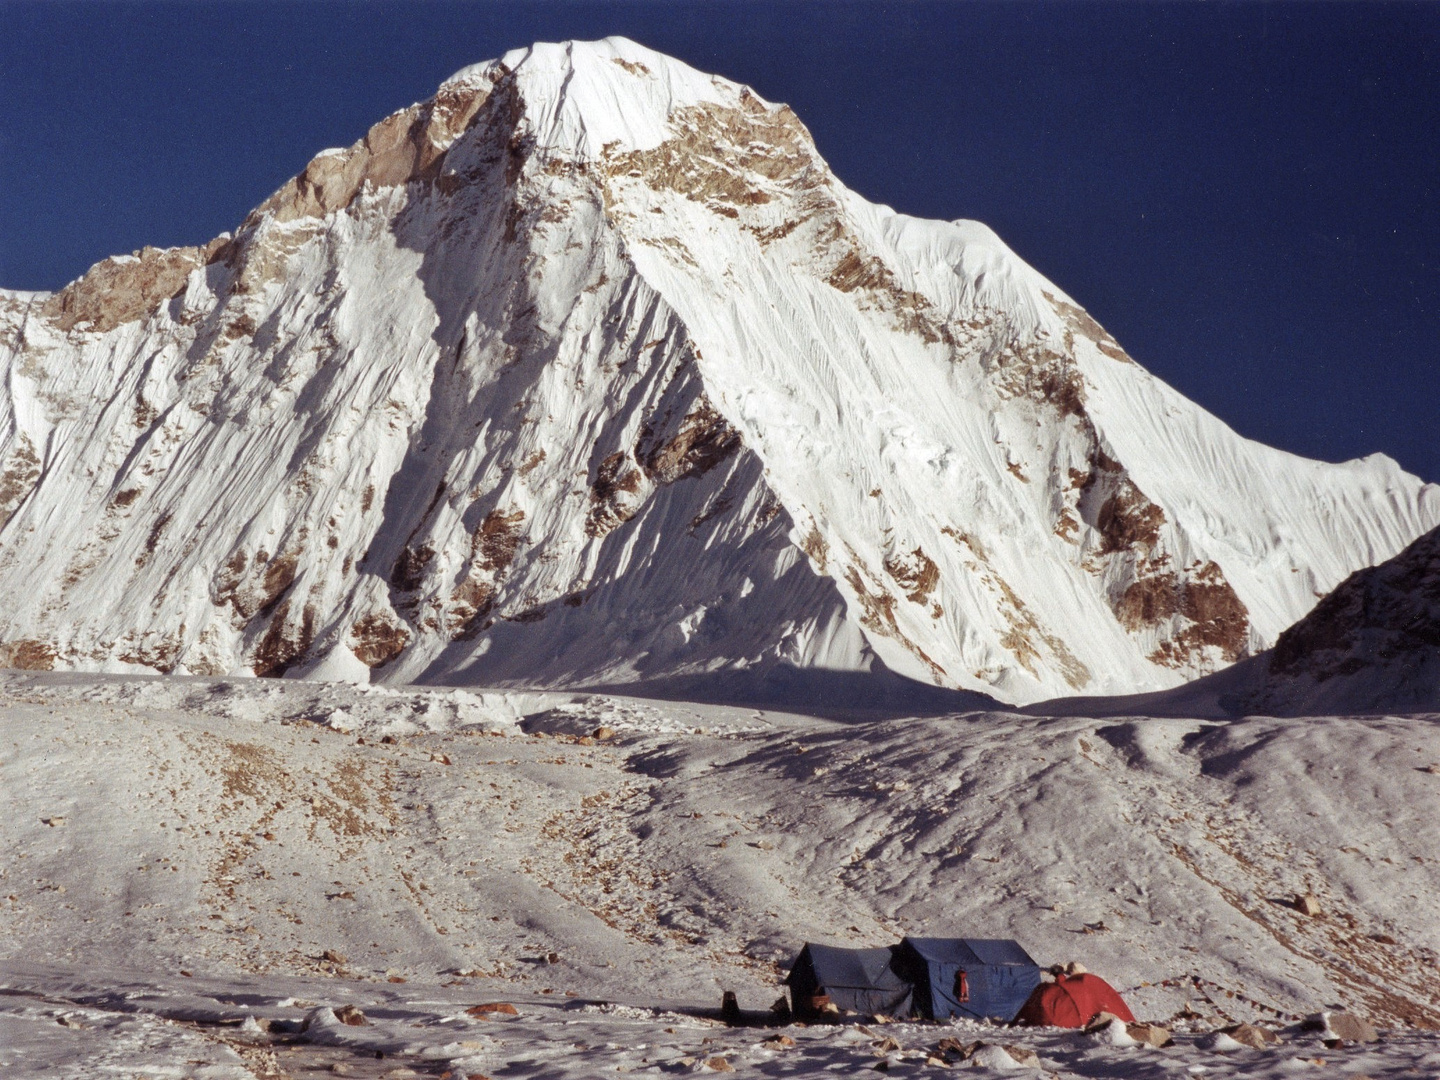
0,672 -> 1440,1077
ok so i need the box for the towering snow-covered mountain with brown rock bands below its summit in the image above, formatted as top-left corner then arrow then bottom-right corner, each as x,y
0,39 -> 1440,701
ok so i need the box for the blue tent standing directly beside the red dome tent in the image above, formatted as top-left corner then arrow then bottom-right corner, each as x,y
894,937 -> 1040,1022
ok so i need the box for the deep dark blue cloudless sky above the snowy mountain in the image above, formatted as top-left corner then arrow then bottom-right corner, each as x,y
0,0 -> 1440,480
